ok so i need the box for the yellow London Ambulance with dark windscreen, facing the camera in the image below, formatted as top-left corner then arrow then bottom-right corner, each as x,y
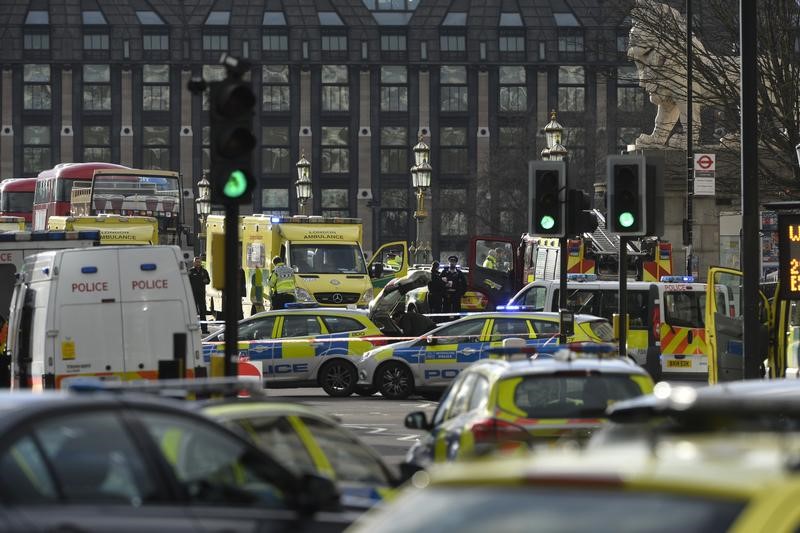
206,214 -> 382,312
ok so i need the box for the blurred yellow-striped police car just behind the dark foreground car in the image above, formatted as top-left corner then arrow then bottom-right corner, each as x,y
201,399 -> 400,511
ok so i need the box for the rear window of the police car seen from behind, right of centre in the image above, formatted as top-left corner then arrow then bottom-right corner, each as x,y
497,371 -> 642,418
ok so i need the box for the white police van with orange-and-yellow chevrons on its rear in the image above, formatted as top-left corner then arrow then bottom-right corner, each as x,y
509,275 -> 732,381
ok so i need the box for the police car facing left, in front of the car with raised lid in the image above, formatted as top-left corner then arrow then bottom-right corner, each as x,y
358,311 -> 613,400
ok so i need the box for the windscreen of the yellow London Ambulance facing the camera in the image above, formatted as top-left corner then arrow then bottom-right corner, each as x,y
290,243 -> 367,275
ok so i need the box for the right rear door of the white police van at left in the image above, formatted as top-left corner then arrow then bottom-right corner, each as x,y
118,246 -> 198,379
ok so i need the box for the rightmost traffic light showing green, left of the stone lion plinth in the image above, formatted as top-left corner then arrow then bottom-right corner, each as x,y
606,155 -> 647,237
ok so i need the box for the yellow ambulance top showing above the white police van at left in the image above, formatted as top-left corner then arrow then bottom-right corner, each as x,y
47,215 -> 158,245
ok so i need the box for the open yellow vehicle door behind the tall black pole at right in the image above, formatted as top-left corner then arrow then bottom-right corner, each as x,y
705,267 -> 770,384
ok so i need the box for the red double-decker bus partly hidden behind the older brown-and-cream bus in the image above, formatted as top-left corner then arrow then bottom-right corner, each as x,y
33,163 -> 129,231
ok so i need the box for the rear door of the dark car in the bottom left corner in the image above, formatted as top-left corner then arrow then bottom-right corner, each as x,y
0,408 -> 196,532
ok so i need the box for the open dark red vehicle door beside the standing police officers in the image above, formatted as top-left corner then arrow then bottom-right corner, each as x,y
467,236 -> 516,311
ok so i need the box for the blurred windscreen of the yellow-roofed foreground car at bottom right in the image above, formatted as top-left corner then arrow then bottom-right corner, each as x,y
354,485 -> 744,533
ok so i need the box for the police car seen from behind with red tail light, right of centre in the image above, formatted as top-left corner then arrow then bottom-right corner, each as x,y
404,343 -> 653,472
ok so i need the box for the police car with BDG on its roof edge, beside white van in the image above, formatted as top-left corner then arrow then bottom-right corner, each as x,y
203,307 -> 386,397
